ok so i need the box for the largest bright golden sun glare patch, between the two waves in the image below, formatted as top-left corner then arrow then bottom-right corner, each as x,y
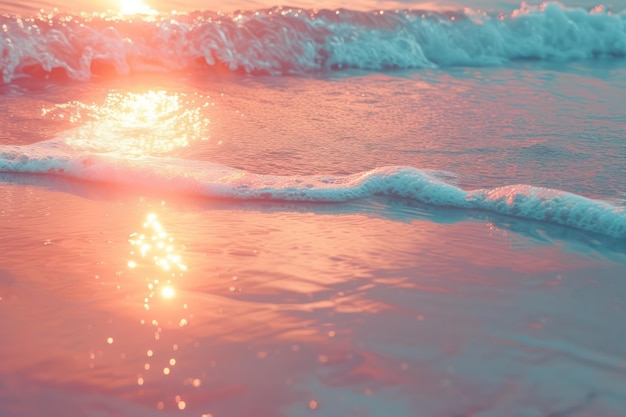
42,90 -> 211,157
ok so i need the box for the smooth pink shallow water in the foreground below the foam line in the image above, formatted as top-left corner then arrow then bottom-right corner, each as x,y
0,178 -> 626,416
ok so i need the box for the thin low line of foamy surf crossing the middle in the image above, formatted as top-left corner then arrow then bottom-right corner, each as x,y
0,141 -> 626,239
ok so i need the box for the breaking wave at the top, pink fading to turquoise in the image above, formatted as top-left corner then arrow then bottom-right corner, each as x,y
0,3 -> 626,83
